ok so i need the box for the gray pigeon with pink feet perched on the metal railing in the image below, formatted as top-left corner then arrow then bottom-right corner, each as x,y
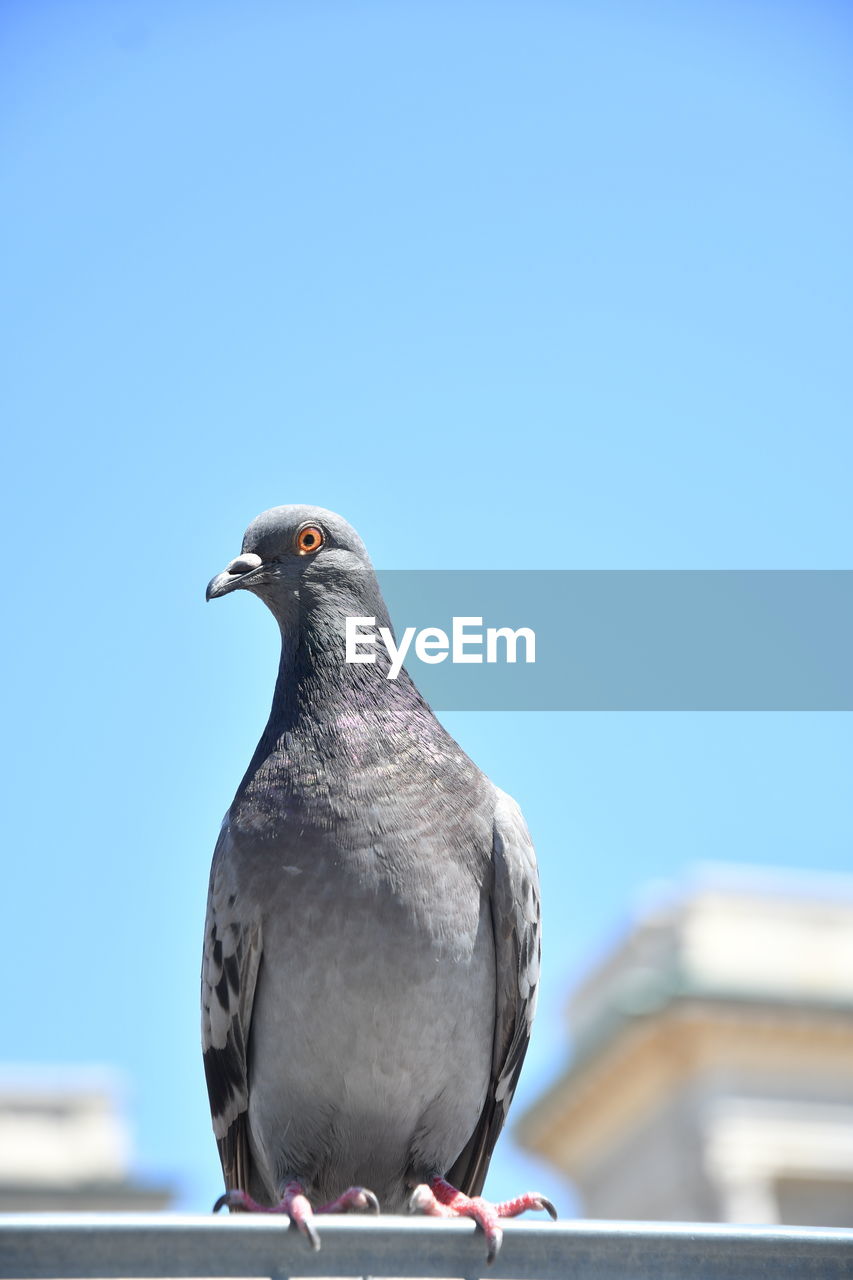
201,506 -> 556,1261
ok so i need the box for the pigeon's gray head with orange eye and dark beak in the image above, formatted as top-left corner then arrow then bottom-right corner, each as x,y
207,506 -> 378,623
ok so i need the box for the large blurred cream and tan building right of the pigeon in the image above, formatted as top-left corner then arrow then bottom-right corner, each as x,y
519,869 -> 853,1226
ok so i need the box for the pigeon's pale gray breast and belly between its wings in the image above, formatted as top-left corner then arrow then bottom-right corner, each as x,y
234,768 -> 496,1208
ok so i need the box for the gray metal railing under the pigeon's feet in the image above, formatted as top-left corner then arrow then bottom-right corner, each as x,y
0,1213 -> 853,1280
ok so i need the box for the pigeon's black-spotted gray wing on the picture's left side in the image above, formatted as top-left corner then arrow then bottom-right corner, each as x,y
201,819 -> 261,1192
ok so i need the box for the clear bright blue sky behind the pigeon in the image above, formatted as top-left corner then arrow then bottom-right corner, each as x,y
0,0 -> 853,1210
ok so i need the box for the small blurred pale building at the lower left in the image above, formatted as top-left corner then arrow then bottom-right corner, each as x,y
0,1068 -> 172,1213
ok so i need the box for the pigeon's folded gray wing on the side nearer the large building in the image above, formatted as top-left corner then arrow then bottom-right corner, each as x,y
447,788 -> 539,1196
